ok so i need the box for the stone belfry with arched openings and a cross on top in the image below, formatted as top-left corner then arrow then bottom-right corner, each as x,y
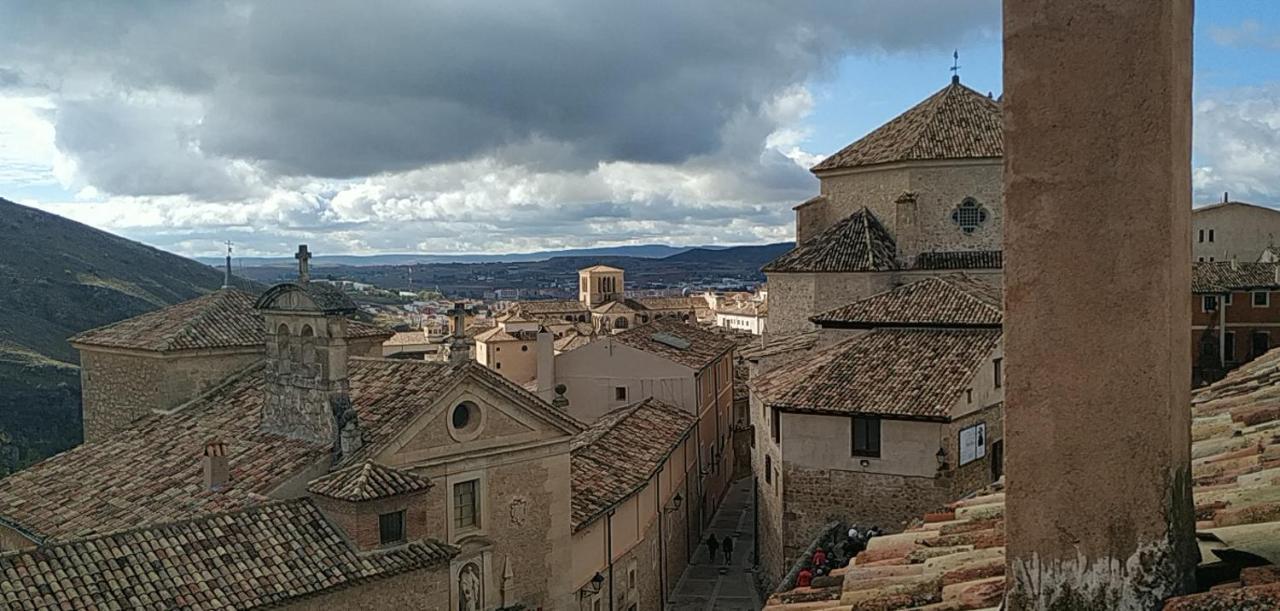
255,246 -> 360,452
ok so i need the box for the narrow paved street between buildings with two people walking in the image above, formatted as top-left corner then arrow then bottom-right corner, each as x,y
667,478 -> 762,611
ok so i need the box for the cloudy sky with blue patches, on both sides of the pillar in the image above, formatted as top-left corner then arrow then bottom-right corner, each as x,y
0,0 -> 1280,255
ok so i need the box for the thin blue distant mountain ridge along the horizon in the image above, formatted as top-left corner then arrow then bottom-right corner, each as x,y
196,243 -> 730,268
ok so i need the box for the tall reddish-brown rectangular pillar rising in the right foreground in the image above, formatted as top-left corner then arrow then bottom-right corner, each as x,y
1004,0 -> 1198,611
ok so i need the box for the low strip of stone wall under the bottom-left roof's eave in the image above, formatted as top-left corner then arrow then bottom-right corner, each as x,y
280,564 -> 457,611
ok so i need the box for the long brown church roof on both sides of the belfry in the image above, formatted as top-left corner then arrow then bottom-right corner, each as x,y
0,359 -> 582,541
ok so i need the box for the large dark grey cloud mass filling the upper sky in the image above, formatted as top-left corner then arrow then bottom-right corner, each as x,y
0,0 -> 998,190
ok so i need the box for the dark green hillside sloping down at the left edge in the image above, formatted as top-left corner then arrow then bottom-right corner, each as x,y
0,199 -> 247,475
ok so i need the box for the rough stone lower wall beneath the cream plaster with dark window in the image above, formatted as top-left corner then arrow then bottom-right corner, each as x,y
782,462 -> 951,560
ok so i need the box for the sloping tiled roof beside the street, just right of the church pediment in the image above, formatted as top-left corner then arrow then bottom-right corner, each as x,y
570,397 -> 694,530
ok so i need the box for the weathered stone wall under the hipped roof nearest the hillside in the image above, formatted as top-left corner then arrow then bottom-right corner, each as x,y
81,347 -> 261,443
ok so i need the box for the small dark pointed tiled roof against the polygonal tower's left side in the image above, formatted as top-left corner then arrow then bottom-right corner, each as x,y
763,208 -> 897,273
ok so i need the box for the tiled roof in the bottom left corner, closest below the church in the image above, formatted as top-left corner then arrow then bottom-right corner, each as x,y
0,500 -> 458,611
